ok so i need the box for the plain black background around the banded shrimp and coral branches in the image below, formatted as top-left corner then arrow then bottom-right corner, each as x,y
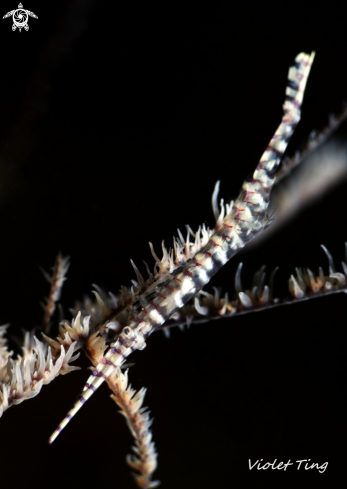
0,0 -> 347,488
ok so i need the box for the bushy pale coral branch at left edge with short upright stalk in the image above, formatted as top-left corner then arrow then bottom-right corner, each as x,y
0,255 -> 89,416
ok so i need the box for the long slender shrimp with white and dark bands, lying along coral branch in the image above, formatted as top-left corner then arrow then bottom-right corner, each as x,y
49,53 -> 314,443
